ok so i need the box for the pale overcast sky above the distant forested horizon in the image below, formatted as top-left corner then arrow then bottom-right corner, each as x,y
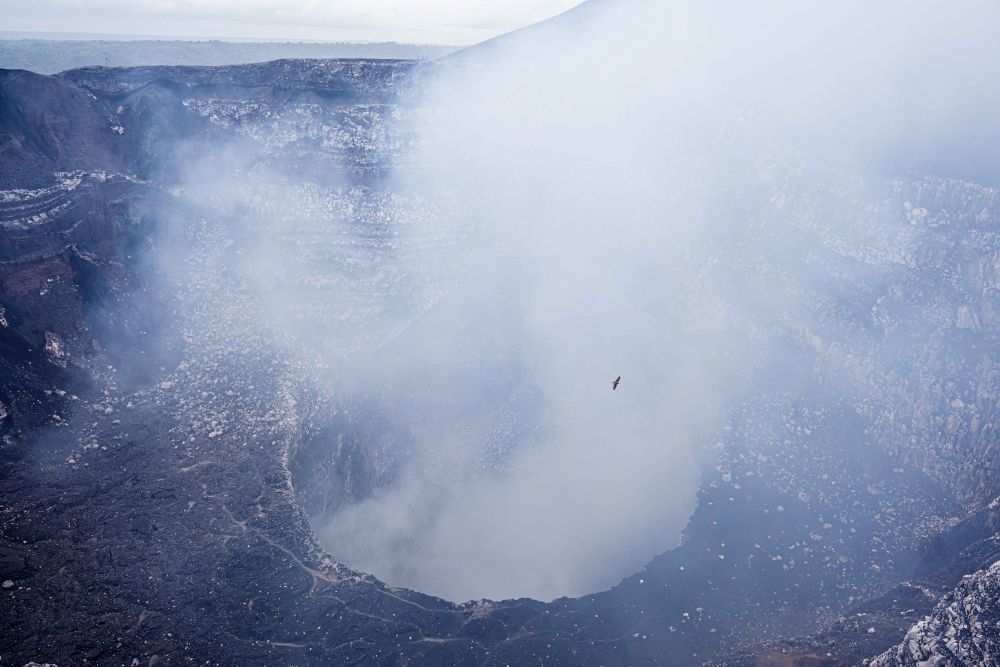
0,0 -> 580,44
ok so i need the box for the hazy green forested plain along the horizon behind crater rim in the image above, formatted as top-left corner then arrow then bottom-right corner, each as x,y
0,39 -> 457,74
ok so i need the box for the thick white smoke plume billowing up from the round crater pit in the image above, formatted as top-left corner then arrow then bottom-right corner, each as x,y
150,0 -> 1000,600
